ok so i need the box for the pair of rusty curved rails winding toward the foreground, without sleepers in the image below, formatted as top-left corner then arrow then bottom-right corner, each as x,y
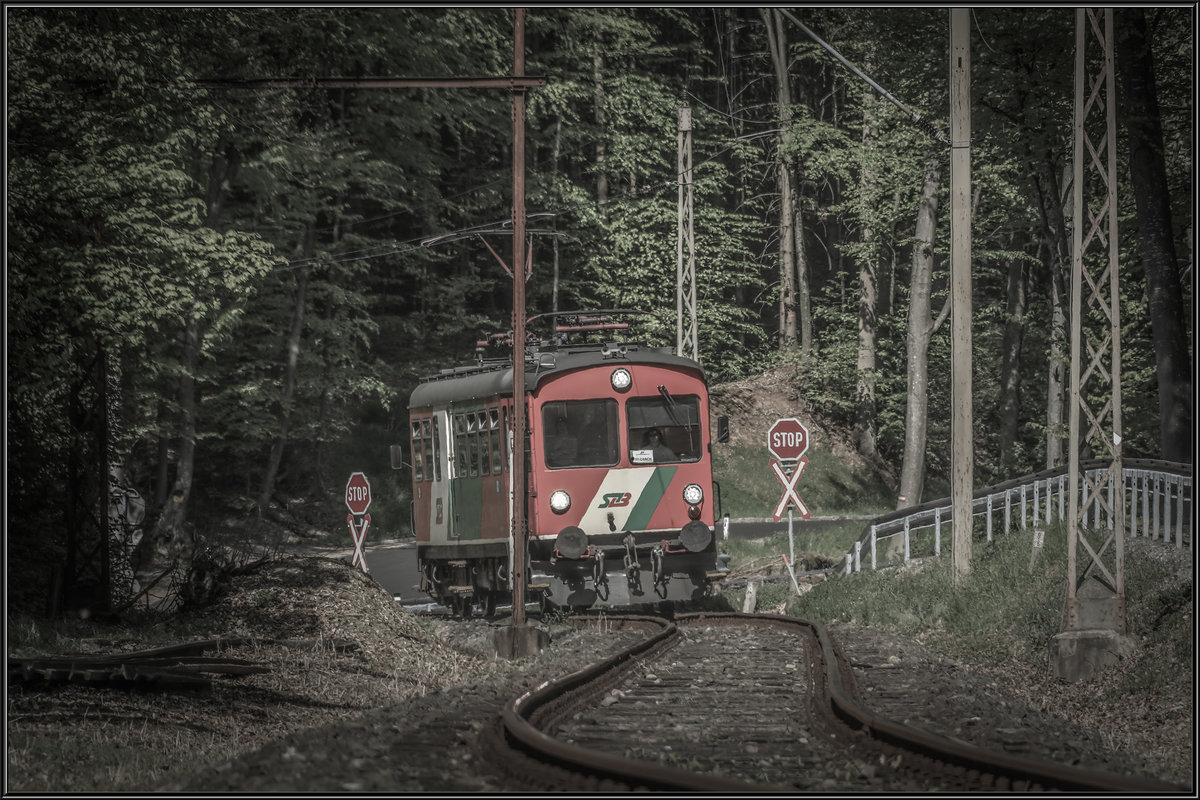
500,613 -> 1183,793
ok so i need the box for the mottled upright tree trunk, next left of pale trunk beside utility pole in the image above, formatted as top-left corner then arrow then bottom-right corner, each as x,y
853,84 -> 878,458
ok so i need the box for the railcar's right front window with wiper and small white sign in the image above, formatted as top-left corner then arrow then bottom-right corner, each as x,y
625,390 -> 701,464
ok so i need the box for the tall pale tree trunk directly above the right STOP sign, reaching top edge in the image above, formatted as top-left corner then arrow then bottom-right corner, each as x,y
758,8 -> 798,350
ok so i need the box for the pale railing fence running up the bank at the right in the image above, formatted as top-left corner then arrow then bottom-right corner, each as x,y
842,459 -> 1195,575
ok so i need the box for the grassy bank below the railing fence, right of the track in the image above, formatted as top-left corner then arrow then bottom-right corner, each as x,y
722,525 -> 1195,783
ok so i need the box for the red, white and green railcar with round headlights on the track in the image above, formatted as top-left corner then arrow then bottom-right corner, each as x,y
409,318 -> 725,613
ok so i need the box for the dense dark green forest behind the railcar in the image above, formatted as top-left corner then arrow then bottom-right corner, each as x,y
6,6 -> 1195,614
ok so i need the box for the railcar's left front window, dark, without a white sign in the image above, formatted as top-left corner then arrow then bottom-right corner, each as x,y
541,399 -> 619,469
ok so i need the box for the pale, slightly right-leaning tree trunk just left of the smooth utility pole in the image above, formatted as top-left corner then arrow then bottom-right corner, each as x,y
896,157 -> 941,509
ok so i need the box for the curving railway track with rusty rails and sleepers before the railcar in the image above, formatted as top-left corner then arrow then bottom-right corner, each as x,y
481,614 -> 1181,792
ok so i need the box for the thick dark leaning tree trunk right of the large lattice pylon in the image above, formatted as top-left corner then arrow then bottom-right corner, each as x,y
1116,6 -> 1193,463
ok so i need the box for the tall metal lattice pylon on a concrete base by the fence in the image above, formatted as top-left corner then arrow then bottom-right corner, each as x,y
1067,8 -> 1126,633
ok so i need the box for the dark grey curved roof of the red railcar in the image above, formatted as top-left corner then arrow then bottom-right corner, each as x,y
408,344 -> 704,408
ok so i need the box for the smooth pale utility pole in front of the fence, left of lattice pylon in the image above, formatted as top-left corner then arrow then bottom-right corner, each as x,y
950,8 -> 974,585
